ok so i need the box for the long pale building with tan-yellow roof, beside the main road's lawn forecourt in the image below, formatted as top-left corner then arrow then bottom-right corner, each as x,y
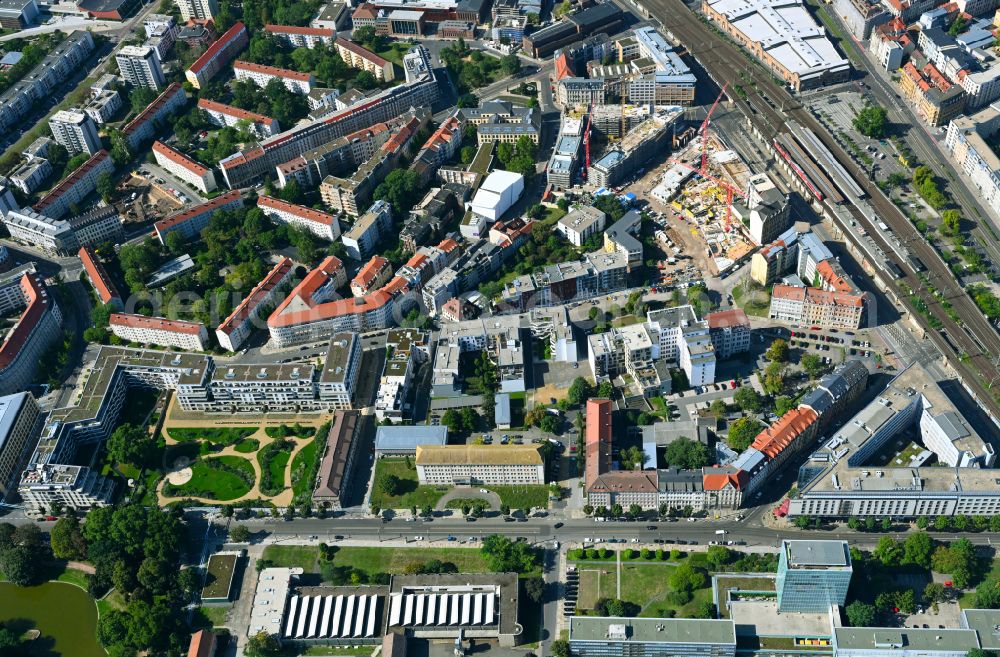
414,445 -> 545,486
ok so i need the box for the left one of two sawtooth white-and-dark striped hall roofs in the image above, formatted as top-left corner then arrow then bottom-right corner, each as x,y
283,595 -> 379,639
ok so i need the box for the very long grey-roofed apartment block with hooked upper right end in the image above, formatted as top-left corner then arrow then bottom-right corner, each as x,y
219,46 -> 439,188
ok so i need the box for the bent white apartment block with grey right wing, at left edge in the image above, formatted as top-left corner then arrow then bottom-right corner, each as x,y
3,206 -> 123,256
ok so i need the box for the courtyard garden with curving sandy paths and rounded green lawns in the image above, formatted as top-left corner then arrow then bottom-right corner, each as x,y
158,423 -> 326,506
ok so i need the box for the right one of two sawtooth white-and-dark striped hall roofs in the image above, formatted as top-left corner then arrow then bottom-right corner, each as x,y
389,591 -> 499,627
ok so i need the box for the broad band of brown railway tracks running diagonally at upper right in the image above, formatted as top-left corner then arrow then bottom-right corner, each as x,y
642,0 -> 1000,418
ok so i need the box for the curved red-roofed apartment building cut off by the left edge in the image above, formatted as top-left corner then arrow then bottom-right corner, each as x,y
0,267 -> 62,395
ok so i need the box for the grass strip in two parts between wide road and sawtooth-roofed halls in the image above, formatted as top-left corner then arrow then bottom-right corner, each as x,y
264,545 -> 487,575
